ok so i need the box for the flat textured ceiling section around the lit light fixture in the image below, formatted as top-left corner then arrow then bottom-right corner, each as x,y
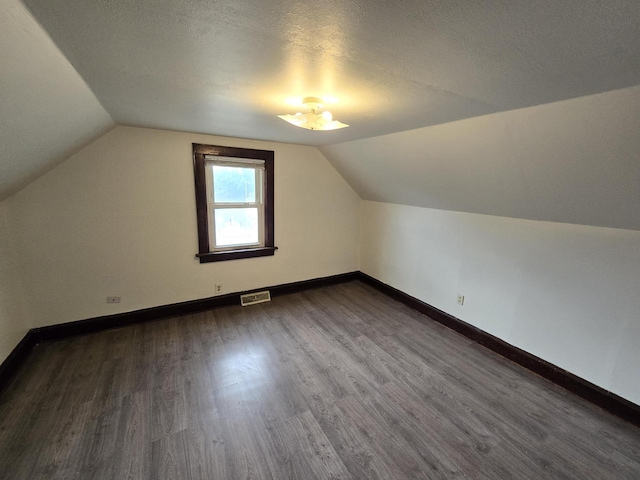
25,0 -> 640,145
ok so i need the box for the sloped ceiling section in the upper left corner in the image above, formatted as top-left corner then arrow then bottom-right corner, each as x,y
0,0 -> 115,201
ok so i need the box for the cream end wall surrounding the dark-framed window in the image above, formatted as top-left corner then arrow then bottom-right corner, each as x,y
8,127 -> 360,326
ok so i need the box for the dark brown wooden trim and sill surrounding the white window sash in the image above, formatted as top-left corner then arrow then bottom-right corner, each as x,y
193,143 -> 278,263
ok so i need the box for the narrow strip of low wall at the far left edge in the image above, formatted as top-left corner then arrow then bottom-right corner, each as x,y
0,202 -> 29,363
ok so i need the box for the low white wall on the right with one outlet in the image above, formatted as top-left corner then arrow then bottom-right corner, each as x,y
361,201 -> 640,404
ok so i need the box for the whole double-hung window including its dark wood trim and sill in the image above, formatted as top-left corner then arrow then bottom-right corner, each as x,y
193,143 -> 276,263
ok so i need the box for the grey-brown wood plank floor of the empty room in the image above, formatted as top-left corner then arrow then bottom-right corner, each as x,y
0,282 -> 640,480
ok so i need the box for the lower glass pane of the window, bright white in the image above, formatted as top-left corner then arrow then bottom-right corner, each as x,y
215,208 -> 259,247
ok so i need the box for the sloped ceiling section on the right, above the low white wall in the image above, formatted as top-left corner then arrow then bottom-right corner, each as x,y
321,86 -> 640,230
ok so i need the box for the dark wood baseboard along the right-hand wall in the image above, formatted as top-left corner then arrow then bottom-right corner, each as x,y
359,272 -> 640,427
